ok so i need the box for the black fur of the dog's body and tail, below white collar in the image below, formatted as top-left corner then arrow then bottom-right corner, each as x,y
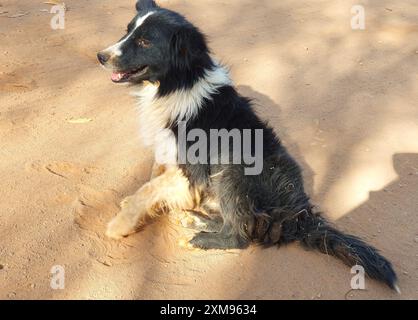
173,86 -> 397,289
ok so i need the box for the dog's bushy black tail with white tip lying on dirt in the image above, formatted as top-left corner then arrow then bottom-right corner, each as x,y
300,216 -> 400,293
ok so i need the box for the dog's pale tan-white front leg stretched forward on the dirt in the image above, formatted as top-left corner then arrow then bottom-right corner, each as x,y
106,167 -> 194,239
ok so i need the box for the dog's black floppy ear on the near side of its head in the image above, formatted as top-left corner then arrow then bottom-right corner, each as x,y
170,26 -> 209,69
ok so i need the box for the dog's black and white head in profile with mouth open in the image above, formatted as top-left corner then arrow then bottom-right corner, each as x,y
97,0 -> 212,89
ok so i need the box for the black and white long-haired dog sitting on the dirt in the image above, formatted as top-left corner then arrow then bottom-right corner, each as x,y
98,0 -> 398,290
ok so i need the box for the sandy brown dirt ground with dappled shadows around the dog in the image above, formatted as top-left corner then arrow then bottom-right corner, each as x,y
0,0 -> 418,299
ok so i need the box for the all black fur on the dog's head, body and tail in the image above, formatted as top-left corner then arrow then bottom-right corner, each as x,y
98,0 -> 397,288
